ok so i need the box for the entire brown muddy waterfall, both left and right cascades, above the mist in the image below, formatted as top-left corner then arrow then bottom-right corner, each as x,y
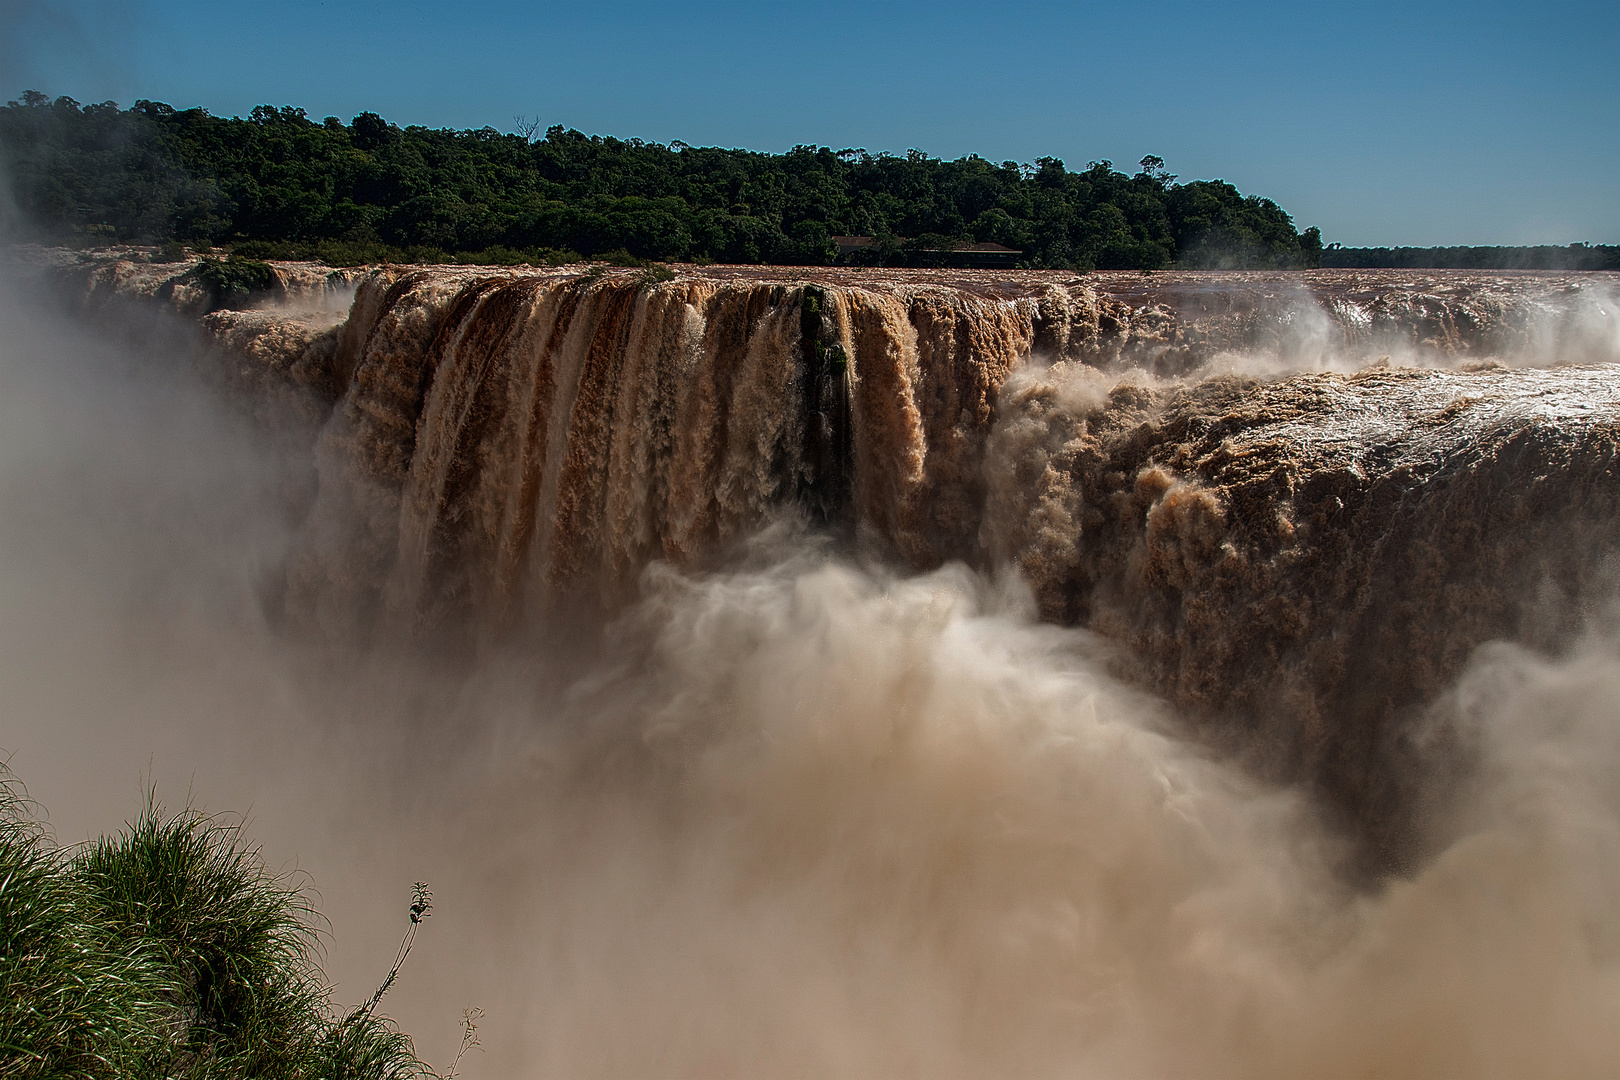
34,254 -> 1620,868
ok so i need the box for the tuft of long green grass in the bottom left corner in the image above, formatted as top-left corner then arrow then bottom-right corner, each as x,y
0,766 -> 433,1080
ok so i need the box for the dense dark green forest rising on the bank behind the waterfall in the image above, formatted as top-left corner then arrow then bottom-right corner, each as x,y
0,91 -> 1322,270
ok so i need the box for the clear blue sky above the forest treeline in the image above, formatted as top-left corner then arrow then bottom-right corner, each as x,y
0,0 -> 1620,244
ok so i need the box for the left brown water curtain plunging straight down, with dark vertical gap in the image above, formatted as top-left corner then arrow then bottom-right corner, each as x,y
280,270 -> 1038,625
